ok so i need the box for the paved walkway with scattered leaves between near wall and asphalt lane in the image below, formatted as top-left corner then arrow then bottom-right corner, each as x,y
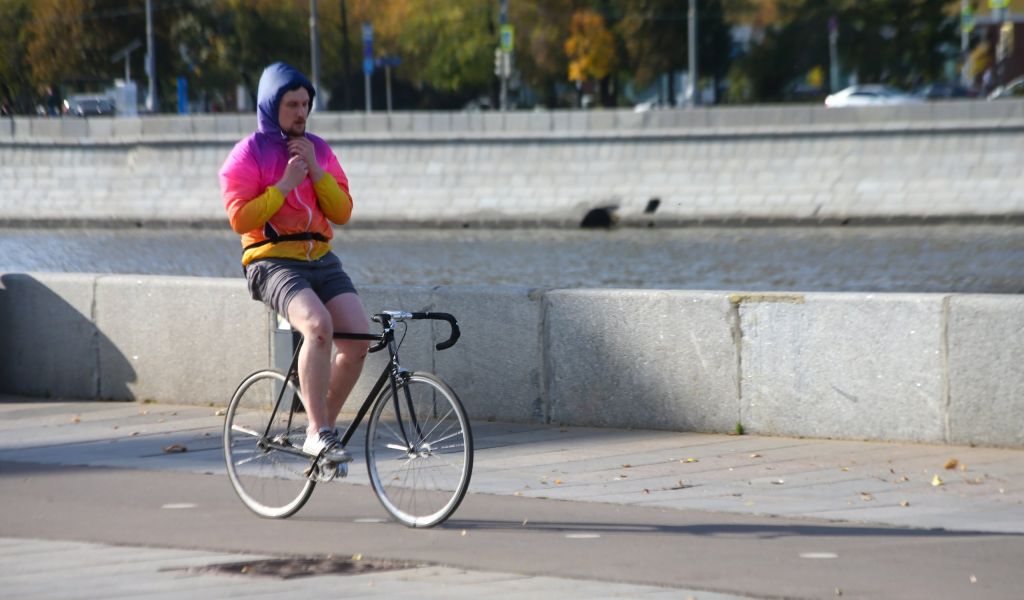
0,395 -> 1024,533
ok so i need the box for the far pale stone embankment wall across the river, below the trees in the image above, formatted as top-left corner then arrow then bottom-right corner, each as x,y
0,100 -> 1024,226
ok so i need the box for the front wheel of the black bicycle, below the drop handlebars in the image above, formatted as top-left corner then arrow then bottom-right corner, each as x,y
367,373 -> 473,527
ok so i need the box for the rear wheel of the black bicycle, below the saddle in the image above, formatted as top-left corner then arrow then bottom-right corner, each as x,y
224,370 -> 316,518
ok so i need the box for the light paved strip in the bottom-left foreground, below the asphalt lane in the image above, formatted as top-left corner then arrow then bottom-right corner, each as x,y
0,538 -> 742,600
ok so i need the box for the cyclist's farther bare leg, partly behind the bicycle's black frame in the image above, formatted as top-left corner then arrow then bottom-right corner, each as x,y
326,294 -> 370,427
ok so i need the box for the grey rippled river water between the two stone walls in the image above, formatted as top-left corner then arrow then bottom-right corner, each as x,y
0,224 -> 1024,294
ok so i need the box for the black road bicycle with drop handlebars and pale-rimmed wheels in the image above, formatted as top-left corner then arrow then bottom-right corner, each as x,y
223,311 -> 473,527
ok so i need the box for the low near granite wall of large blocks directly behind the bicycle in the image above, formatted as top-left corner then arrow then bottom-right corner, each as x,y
0,273 -> 1024,447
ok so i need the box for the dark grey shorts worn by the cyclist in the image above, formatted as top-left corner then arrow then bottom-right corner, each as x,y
246,252 -> 356,318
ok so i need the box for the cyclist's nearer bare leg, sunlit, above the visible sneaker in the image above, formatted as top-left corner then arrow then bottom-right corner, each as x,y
288,289 -> 334,435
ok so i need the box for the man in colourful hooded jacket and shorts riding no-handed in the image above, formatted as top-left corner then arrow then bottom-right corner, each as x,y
219,62 -> 370,463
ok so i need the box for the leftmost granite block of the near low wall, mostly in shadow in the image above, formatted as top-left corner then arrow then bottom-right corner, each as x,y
0,273 -> 100,399
